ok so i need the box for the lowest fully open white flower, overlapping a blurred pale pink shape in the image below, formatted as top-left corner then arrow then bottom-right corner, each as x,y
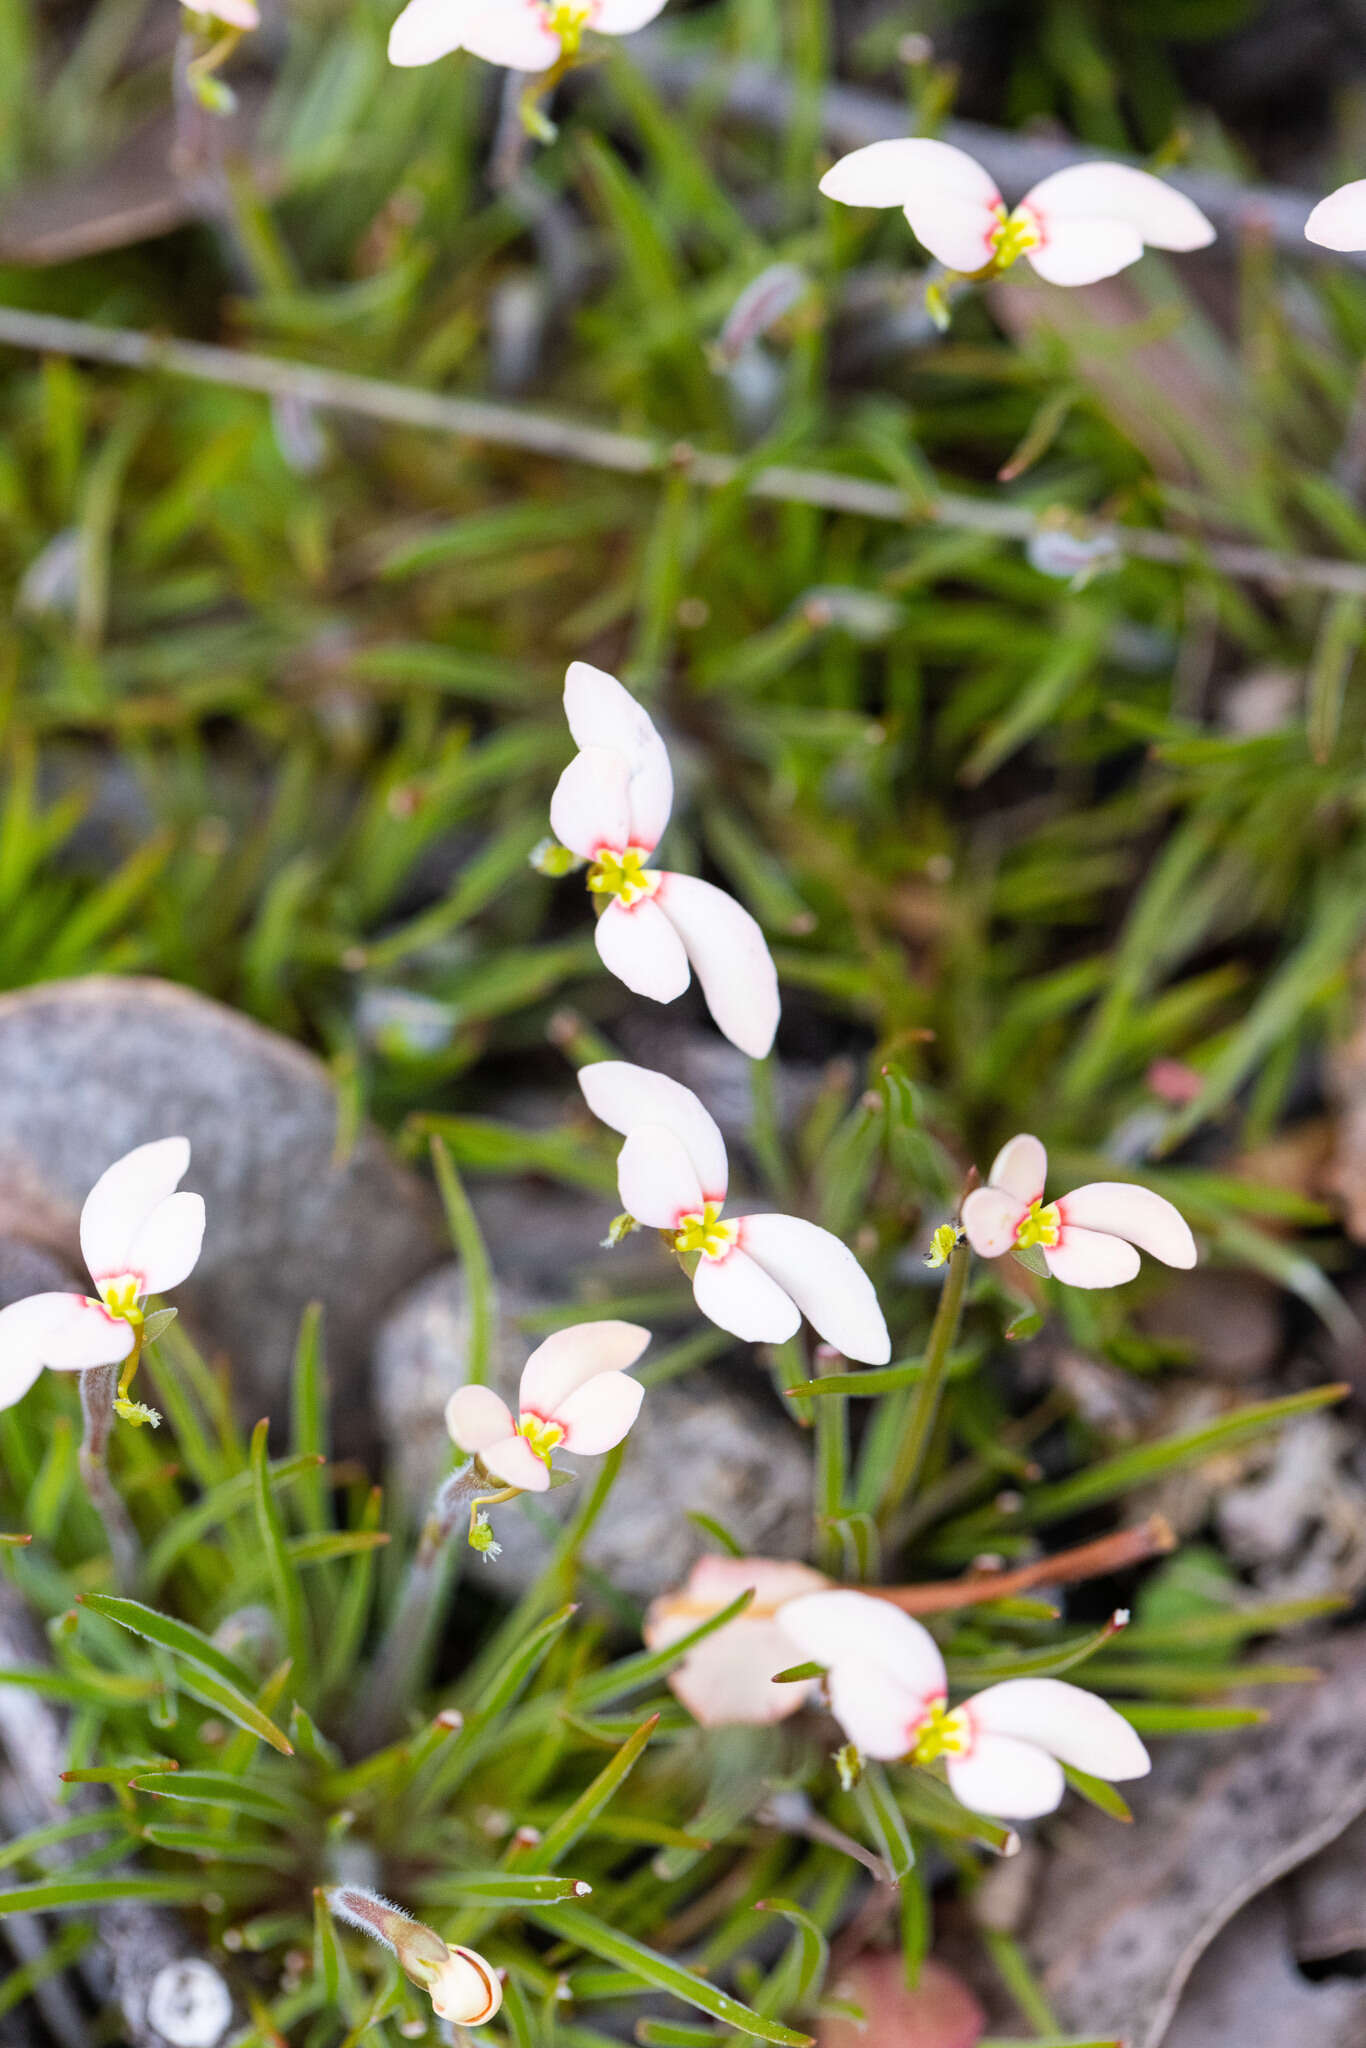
780,1591 -> 1151,1821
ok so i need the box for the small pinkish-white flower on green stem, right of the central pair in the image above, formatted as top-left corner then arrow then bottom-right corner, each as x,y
963,1135 -> 1196,1286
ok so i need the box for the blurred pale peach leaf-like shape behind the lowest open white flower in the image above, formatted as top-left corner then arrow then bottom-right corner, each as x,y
643,1556 -> 829,1729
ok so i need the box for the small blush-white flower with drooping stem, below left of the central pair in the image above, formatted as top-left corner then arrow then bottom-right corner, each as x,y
446,1323 -> 649,1493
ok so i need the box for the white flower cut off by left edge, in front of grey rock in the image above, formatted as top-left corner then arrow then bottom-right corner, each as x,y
0,1139 -> 205,1407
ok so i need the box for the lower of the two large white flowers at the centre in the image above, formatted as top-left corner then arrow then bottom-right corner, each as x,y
580,1059 -> 891,1366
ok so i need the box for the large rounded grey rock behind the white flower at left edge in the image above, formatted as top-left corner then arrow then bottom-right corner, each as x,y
0,975 -> 446,1444
